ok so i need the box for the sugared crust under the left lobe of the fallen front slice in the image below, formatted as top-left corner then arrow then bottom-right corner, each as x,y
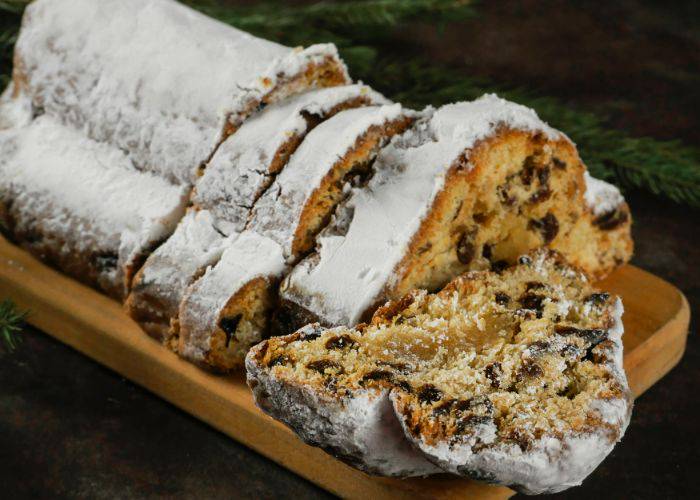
246,328 -> 442,477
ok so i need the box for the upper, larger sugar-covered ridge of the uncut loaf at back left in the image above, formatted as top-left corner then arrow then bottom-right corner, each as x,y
14,0 -> 349,184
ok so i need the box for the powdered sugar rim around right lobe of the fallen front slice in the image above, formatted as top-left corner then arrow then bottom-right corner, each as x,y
392,298 -> 632,494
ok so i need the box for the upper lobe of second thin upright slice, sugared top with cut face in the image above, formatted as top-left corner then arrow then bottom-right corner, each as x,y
248,104 -> 414,262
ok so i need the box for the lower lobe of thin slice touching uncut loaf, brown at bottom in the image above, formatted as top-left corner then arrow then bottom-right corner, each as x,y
125,210 -> 238,342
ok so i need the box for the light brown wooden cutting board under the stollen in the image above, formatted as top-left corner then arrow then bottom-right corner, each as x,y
0,238 -> 690,499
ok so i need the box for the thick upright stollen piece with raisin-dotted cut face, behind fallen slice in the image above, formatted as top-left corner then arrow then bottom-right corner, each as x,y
276,95 -> 632,333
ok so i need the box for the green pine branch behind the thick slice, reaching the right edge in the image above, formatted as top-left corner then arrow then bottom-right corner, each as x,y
355,55 -> 700,207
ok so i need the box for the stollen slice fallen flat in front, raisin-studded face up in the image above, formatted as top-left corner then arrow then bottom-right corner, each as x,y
246,250 -> 632,494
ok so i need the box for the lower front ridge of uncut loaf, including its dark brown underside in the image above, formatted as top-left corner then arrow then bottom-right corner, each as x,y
0,116 -> 187,299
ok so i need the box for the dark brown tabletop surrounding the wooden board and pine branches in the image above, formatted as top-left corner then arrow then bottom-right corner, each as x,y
0,1 -> 700,498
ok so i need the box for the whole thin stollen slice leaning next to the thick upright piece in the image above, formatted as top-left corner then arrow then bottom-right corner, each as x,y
175,104 -> 415,371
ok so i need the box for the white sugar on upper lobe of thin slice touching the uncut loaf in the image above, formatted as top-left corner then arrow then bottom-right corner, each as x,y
193,84 -> 387,234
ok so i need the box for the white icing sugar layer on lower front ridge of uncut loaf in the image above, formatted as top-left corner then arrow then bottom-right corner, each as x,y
0,115 -> 187,292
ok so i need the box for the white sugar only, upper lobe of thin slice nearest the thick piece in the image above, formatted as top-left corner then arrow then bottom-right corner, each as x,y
248,104 -> 402,260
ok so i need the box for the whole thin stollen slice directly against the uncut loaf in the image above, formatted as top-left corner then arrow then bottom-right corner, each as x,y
126,84 -> 387,341
